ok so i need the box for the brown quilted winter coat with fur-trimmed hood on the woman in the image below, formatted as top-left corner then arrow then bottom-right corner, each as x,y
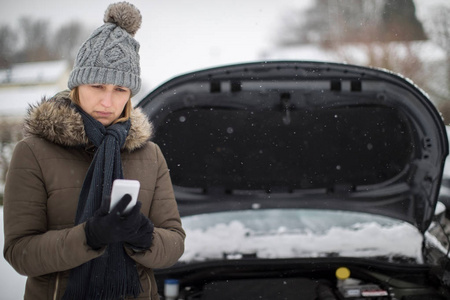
4,91 -> 185,300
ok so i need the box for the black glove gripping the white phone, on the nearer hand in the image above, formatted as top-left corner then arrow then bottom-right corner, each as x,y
85,194 -> 142,249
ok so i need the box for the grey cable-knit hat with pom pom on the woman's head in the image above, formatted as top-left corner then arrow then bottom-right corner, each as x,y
68,2 -> 142,95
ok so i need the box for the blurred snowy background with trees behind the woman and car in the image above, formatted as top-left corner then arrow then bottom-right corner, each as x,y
0,0 -> 450,204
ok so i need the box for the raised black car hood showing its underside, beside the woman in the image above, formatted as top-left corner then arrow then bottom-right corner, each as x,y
138,61 -> 448,232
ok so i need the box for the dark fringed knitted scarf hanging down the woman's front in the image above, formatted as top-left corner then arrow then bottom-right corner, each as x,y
63,105 -> 141,300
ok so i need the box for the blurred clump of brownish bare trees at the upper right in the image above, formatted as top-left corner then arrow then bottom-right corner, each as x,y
278,0 -> 426,45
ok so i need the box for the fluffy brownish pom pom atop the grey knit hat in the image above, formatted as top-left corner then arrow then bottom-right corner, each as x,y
103,2 -> 142,36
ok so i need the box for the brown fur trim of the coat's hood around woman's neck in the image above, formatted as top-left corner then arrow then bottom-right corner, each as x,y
24,90 -> 153,151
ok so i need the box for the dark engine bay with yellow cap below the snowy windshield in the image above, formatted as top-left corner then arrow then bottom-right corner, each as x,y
155,259 -> 450,300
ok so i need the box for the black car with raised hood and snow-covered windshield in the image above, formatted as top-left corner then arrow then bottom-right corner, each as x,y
137,61 -> 450,300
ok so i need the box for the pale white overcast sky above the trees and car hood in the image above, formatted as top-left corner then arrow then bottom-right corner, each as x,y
0,0 -> 450,96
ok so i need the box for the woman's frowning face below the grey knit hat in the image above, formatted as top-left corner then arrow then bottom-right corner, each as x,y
78,84 -> 131,126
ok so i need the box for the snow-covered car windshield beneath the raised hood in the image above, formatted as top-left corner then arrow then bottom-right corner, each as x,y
180,209 -> 423,263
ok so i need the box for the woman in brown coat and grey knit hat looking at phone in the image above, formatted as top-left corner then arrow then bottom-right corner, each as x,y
4,2 -> 185,300
